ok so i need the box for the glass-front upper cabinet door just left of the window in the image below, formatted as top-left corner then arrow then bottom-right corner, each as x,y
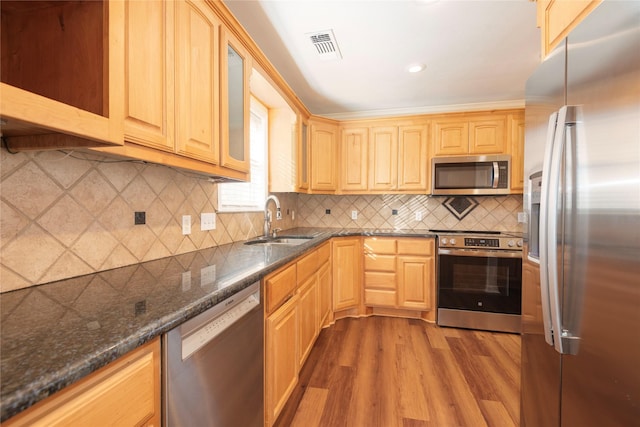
220,28 -> 251,172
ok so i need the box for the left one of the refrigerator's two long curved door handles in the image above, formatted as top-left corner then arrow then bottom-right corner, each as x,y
539,112 -> 558,347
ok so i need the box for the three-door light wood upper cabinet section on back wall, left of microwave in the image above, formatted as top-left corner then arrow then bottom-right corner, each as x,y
339,122 -> 428,194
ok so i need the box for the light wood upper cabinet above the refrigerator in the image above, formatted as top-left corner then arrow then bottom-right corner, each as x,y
537,0 -> 602,59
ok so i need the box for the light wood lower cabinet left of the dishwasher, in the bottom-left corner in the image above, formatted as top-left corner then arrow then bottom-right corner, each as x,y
2,338 -> 160,427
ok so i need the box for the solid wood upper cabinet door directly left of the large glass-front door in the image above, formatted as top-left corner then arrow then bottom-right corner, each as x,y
175,0 -> 220,164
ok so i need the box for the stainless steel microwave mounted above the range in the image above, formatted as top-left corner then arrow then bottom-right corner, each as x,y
431,155 -> 511,195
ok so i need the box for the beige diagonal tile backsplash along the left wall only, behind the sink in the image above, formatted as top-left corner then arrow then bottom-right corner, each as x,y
0,148 -> 296,292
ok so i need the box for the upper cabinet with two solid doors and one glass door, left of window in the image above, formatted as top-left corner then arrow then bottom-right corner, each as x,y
99,0 -> 250,180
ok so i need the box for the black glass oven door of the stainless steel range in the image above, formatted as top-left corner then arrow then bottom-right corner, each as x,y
438,249 -> 522,315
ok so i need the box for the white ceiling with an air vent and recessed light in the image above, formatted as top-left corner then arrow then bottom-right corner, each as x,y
224,0 -> 540,119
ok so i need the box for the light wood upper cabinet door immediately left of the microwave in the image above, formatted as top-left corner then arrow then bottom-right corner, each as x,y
398,125 -> 429,192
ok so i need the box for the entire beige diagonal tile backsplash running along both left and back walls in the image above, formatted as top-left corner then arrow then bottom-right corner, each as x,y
0,148 -> 522,292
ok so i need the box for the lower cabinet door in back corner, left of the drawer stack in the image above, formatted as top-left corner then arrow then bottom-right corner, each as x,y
331,238 -> 362,311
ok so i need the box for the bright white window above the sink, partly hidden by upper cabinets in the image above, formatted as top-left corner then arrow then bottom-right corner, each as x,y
218,97 -> 269,212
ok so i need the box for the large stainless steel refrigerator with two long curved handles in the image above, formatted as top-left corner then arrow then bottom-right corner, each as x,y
521,0 -> 640,427
